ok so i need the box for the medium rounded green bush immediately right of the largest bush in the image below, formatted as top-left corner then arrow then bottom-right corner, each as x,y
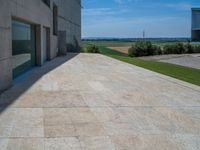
163,42 -> 185,54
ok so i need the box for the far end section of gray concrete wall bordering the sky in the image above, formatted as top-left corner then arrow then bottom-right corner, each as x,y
55,0 -> 81,51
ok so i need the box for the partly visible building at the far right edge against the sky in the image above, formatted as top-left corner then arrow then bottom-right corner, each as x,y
192,8 -> 200,42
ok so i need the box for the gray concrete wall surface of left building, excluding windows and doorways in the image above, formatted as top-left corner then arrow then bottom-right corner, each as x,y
0,0 -> 81,92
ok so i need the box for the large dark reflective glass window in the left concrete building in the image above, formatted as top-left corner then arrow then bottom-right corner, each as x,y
12,20 -> 35,77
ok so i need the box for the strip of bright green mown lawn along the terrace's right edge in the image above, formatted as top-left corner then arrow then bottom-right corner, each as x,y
99,46 -> 200,86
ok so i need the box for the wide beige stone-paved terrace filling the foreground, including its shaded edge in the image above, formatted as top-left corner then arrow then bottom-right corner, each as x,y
0,54 -> 200,150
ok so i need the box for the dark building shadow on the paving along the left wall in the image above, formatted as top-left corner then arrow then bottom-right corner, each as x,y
0,53 -> 78,114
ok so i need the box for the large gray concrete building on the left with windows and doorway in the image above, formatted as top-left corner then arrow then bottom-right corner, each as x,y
0,0 -> 81,92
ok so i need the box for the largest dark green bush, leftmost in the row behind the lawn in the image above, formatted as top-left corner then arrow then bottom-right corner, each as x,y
128,41 -> 162,57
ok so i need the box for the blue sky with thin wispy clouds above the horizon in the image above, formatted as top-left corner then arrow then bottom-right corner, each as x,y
82,0 -> 200,38
